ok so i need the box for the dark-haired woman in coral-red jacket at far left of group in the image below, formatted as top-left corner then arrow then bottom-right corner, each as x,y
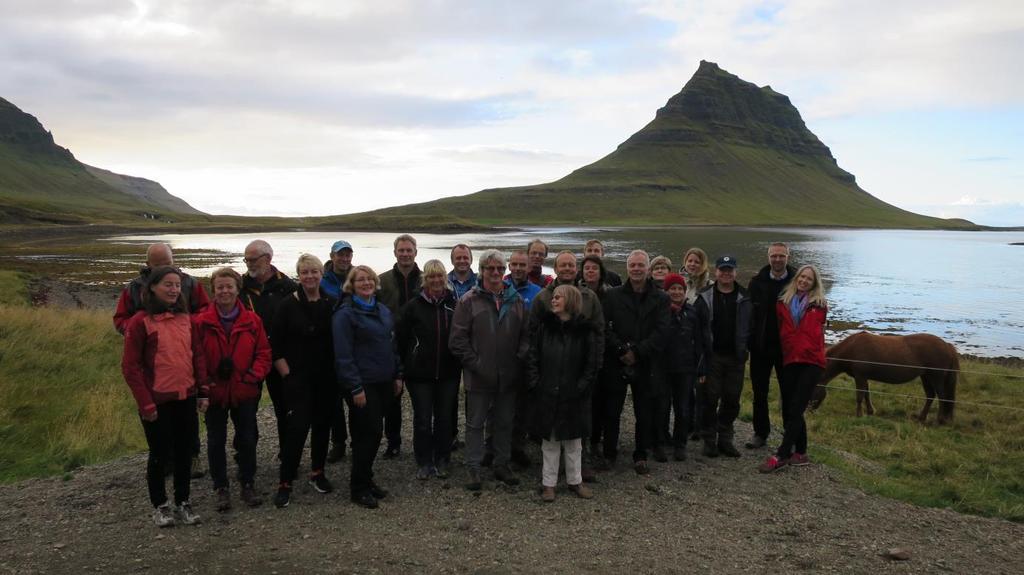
121,266 -> 208,527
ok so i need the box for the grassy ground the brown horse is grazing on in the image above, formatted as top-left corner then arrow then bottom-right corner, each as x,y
743,360 -> 1024,522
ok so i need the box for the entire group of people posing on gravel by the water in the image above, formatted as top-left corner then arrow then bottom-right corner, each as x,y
115,234 -> 827,526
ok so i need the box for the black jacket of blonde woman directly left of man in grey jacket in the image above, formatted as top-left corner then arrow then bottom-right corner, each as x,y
394,290 -> 462,382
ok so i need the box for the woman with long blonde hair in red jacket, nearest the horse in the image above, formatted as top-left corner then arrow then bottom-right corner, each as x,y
758,266 -> 828,473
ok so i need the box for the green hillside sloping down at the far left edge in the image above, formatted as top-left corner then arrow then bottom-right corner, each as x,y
0,98 -> 204,224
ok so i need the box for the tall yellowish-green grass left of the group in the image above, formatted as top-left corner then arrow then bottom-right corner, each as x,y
0,305 -> 145,482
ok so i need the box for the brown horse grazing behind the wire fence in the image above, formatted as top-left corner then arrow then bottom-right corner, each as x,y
810,331 -> 959,424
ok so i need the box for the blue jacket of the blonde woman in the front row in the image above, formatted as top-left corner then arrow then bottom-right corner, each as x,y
332,294 -> 401,395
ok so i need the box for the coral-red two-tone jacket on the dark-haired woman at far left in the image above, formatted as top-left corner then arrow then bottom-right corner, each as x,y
121,311 -> 207,415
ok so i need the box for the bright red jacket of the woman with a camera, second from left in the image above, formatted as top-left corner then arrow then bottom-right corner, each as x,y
196,303 -> 270,407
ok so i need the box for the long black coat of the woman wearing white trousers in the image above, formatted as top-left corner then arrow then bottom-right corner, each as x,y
527,312 -> 601,440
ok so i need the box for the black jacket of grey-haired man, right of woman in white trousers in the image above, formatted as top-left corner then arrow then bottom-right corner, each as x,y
603,278 -> 670,391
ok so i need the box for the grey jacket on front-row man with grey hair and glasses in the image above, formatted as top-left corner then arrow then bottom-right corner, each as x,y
449,285 -> 529,392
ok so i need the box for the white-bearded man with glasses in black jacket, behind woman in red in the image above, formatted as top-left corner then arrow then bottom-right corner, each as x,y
239,239 -> 298,456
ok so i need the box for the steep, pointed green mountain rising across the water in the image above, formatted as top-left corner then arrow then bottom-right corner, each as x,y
367,61 -> 977,228
